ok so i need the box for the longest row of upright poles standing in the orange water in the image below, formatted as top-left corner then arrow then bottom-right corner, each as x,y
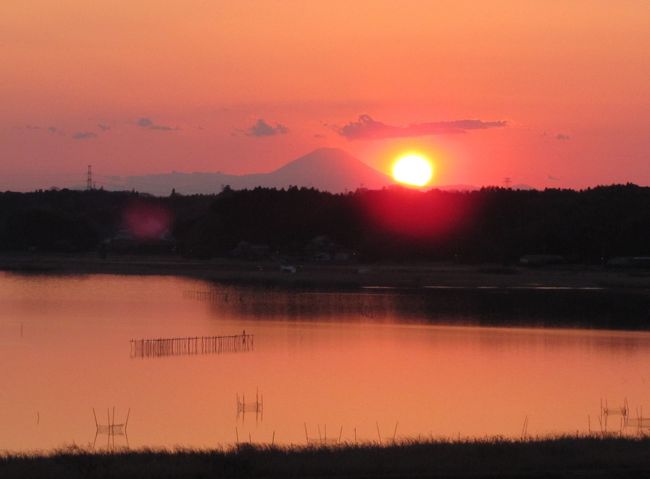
131,331 -> 255,358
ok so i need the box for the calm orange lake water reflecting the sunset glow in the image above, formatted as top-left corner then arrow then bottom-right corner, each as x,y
0,273 -> 650,451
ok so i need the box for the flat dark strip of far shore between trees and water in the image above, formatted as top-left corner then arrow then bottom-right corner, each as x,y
0,253 -> 650,292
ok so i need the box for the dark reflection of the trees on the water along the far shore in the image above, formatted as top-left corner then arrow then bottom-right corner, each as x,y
185,286 -> 649,329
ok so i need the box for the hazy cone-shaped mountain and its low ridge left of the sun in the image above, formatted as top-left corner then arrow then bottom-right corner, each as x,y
106,148 -> 393,196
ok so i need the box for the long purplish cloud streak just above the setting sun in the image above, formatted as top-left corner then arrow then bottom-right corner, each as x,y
337,115 -> 507,140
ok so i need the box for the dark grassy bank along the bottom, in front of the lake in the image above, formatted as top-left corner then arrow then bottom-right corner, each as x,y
0,437 -> 650,479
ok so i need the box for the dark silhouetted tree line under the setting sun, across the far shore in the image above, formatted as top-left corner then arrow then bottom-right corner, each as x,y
0,184 -> 650,264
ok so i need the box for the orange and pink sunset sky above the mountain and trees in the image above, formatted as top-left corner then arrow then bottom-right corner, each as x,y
0,0 -> 650,190
